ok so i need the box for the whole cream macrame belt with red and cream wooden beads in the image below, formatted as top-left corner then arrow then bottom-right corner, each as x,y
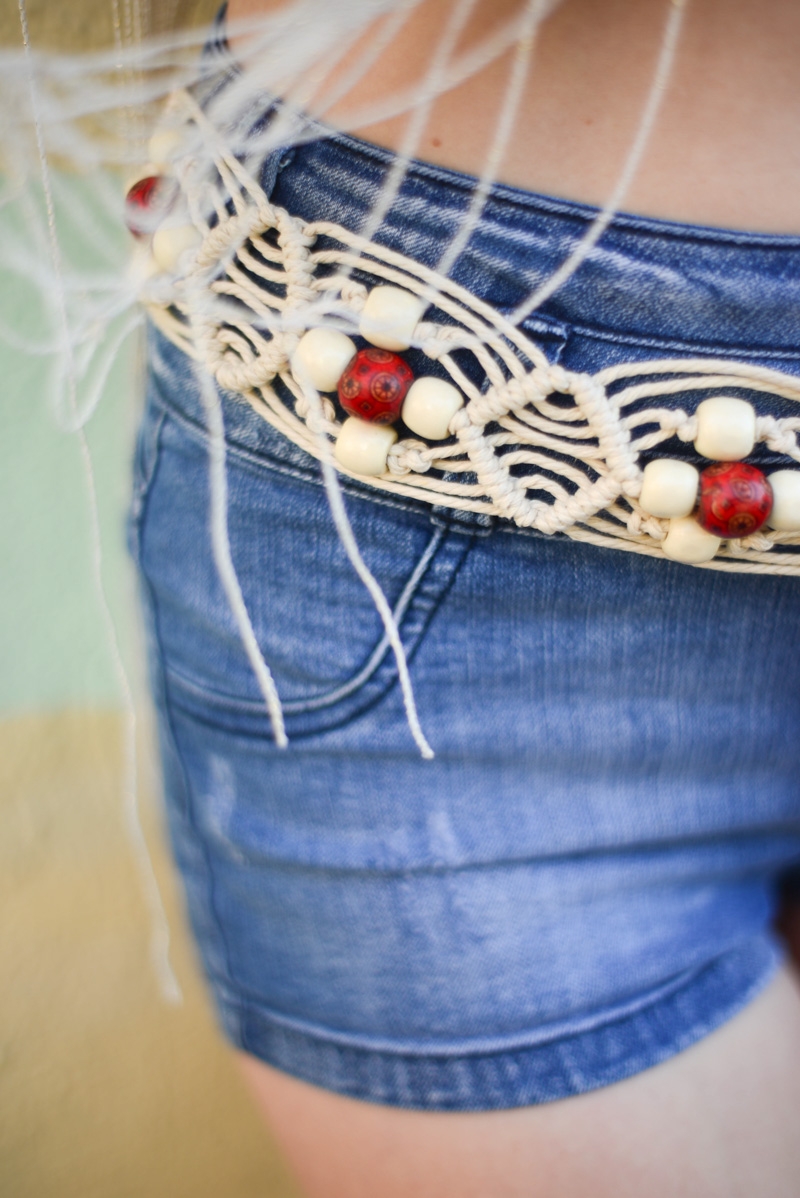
127,93 -> 800,575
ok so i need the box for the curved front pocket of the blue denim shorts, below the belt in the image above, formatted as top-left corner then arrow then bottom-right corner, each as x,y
141,416 -> 472,737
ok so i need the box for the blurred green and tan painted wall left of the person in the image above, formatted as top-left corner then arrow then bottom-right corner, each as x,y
0,0 -> 297,1198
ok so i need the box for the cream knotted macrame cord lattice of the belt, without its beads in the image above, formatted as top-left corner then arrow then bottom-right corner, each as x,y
144,89 -> 800,574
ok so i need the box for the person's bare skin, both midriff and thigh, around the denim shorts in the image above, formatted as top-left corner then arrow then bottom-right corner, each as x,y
219,0 -> 800,1198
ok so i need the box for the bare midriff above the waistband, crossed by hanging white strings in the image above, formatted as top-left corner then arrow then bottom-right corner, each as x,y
229,0 -> 800,234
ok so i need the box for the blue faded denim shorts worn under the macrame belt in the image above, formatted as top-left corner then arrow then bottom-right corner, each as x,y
132,116 -> 800,1111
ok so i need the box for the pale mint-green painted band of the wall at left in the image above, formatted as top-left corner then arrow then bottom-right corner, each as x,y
0,168 -> 143,713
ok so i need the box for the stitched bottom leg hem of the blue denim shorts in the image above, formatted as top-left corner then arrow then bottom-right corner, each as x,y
212,936 -> 783,1111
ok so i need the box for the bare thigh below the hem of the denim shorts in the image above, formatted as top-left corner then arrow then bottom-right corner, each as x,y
241,969 -> 800,1198
